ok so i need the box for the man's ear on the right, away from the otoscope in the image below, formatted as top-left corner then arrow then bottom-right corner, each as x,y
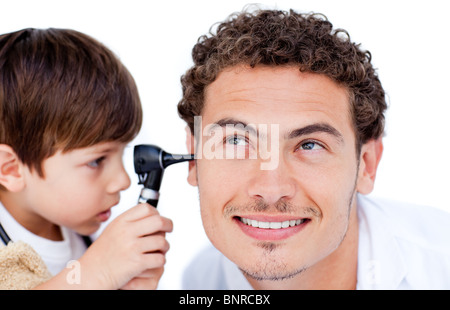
356,138 -> 383,195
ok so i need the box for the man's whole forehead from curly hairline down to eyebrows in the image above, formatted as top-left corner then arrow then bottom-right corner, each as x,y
202,67 -> 352,127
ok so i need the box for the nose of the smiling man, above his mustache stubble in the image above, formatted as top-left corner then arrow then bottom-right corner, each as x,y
248,158 -> 296,204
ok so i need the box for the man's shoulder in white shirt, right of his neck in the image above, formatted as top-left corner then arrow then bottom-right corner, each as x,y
358,197 -> 450,289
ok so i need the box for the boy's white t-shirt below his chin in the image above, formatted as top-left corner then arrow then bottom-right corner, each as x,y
0,203 -> 86,275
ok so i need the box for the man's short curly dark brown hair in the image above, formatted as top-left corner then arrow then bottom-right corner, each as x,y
178,10 -> 387,151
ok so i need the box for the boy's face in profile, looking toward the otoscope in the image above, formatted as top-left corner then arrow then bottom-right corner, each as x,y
22,142 -> 130,235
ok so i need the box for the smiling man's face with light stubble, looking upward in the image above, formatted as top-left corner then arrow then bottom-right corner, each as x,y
189,66 -> 359,280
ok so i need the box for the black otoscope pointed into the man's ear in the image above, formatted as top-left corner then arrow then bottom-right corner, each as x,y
134,144 -> 194,208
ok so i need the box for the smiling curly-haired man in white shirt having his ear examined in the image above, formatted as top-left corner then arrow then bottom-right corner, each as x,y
178,10 -> 450,289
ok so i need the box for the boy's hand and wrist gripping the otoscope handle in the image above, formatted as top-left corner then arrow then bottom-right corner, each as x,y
79,204 -> 173,289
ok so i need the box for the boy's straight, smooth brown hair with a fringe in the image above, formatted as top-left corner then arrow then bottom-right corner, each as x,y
0,29 -> 142,177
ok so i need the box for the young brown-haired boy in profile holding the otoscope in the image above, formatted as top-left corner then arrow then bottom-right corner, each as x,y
0,29 -> 172,289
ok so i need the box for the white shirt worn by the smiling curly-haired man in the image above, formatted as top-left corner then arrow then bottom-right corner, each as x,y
183,195 -> 450,290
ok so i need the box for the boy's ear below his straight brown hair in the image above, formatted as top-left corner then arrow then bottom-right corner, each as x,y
0,144 -> 25,192
